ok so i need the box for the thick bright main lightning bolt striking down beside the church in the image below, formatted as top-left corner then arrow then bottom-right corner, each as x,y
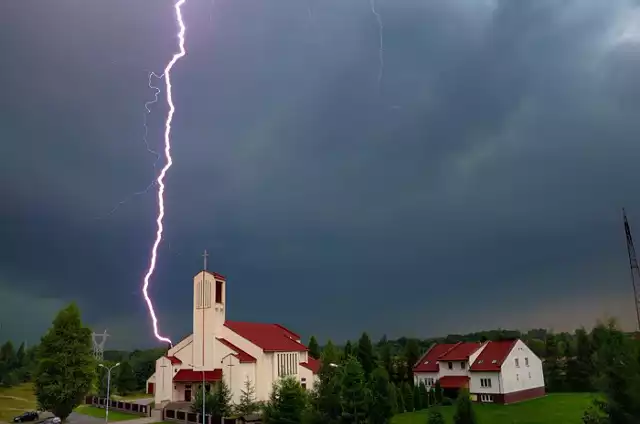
142,0 -> 187,344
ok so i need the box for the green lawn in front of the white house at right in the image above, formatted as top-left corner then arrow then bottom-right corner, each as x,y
392,393 -> 594,424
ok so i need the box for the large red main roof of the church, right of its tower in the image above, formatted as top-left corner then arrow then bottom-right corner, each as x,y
224,321 -> 307,352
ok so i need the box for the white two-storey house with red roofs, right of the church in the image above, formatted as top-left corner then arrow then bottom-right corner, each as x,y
413,340 -> 545,404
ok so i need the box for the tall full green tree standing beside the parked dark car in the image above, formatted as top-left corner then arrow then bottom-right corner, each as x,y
34,303 -> 96,420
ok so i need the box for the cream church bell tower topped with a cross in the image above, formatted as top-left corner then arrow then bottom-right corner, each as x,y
192,250 -> 226,370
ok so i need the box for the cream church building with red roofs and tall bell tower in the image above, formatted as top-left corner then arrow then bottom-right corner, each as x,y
147,271 -> 320,406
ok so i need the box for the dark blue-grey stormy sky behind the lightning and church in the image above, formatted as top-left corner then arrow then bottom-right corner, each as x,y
0,0 -> 640,348
